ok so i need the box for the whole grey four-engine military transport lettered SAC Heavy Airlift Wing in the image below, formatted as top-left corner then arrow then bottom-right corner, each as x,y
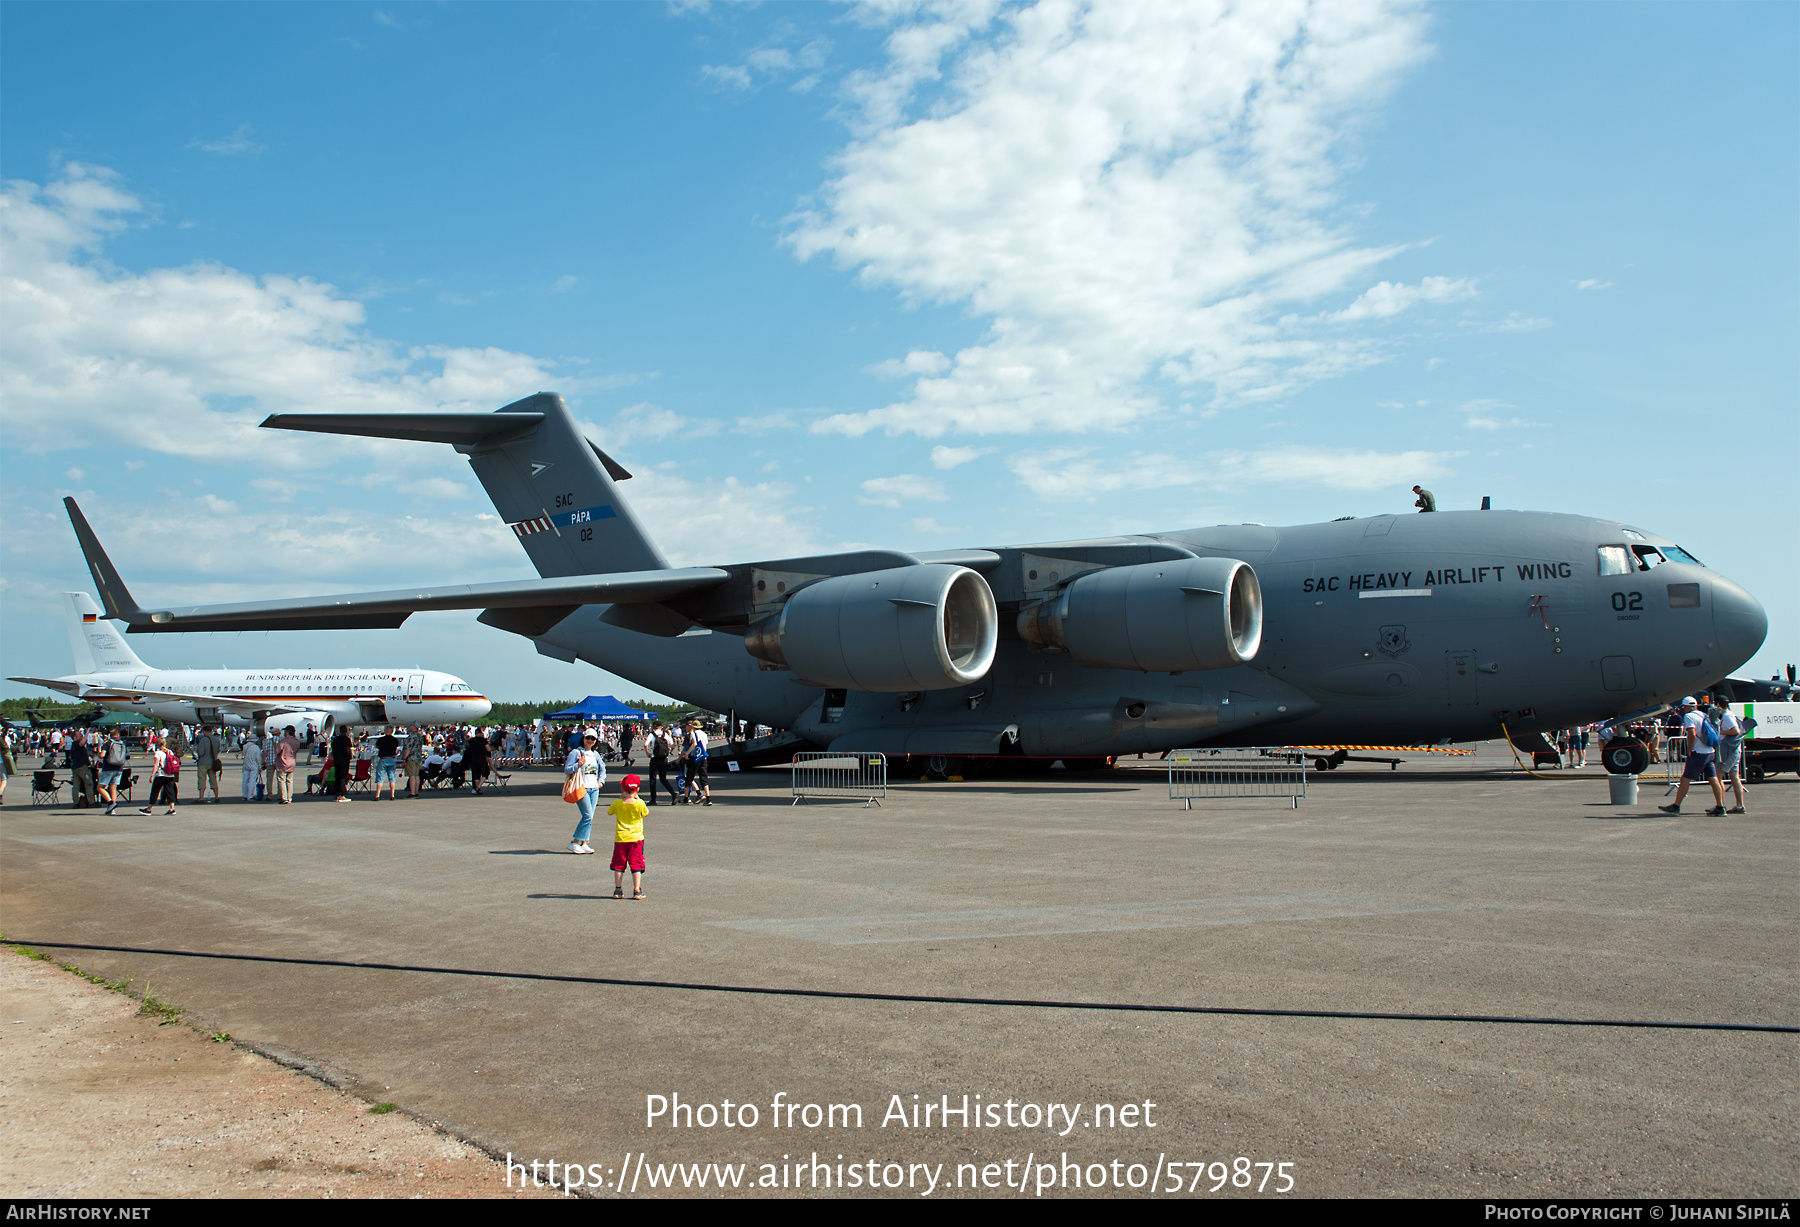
68,392 -> 1768,759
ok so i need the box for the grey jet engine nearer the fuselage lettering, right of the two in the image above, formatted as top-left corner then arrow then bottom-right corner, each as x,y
1019,558 -> 1262,673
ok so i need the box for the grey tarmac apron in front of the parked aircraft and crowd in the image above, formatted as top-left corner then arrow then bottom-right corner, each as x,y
0,747 -> 1800,1198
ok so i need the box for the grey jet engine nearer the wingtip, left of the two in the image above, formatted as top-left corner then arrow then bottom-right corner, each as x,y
743,563 -> 999,693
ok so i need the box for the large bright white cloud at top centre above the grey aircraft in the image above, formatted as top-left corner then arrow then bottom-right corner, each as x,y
788,0 -> 1440,437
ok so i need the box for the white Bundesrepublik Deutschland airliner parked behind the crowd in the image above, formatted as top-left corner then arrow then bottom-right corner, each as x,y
7,592 -> 493,734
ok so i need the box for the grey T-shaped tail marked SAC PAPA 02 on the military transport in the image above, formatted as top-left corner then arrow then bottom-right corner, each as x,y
263,392 -> 670,579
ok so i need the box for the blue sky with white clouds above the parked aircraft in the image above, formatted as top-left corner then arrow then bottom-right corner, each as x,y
0,2 -> 1800,700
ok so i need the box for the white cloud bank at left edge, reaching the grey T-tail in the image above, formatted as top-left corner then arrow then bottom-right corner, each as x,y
0,164 -> 574,468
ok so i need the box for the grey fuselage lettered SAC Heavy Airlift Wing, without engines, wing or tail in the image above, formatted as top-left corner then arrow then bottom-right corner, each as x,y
538,511 -> 1766,756
